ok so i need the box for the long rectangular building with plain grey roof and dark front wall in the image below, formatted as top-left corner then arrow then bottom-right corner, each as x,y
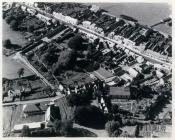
109,87 -> 131,99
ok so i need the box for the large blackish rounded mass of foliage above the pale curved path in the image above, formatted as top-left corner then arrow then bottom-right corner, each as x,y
74,105 -> 105,128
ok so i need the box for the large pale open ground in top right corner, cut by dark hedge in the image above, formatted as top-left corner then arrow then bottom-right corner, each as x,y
92,3 -> 172,34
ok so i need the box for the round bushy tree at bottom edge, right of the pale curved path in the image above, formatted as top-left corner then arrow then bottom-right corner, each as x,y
105,120 -> 120,136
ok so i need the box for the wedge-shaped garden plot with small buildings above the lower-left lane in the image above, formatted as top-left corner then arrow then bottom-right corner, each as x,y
3,75 -> 54,102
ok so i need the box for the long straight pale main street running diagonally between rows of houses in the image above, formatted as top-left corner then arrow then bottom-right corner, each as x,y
18,3 -> 171,70
